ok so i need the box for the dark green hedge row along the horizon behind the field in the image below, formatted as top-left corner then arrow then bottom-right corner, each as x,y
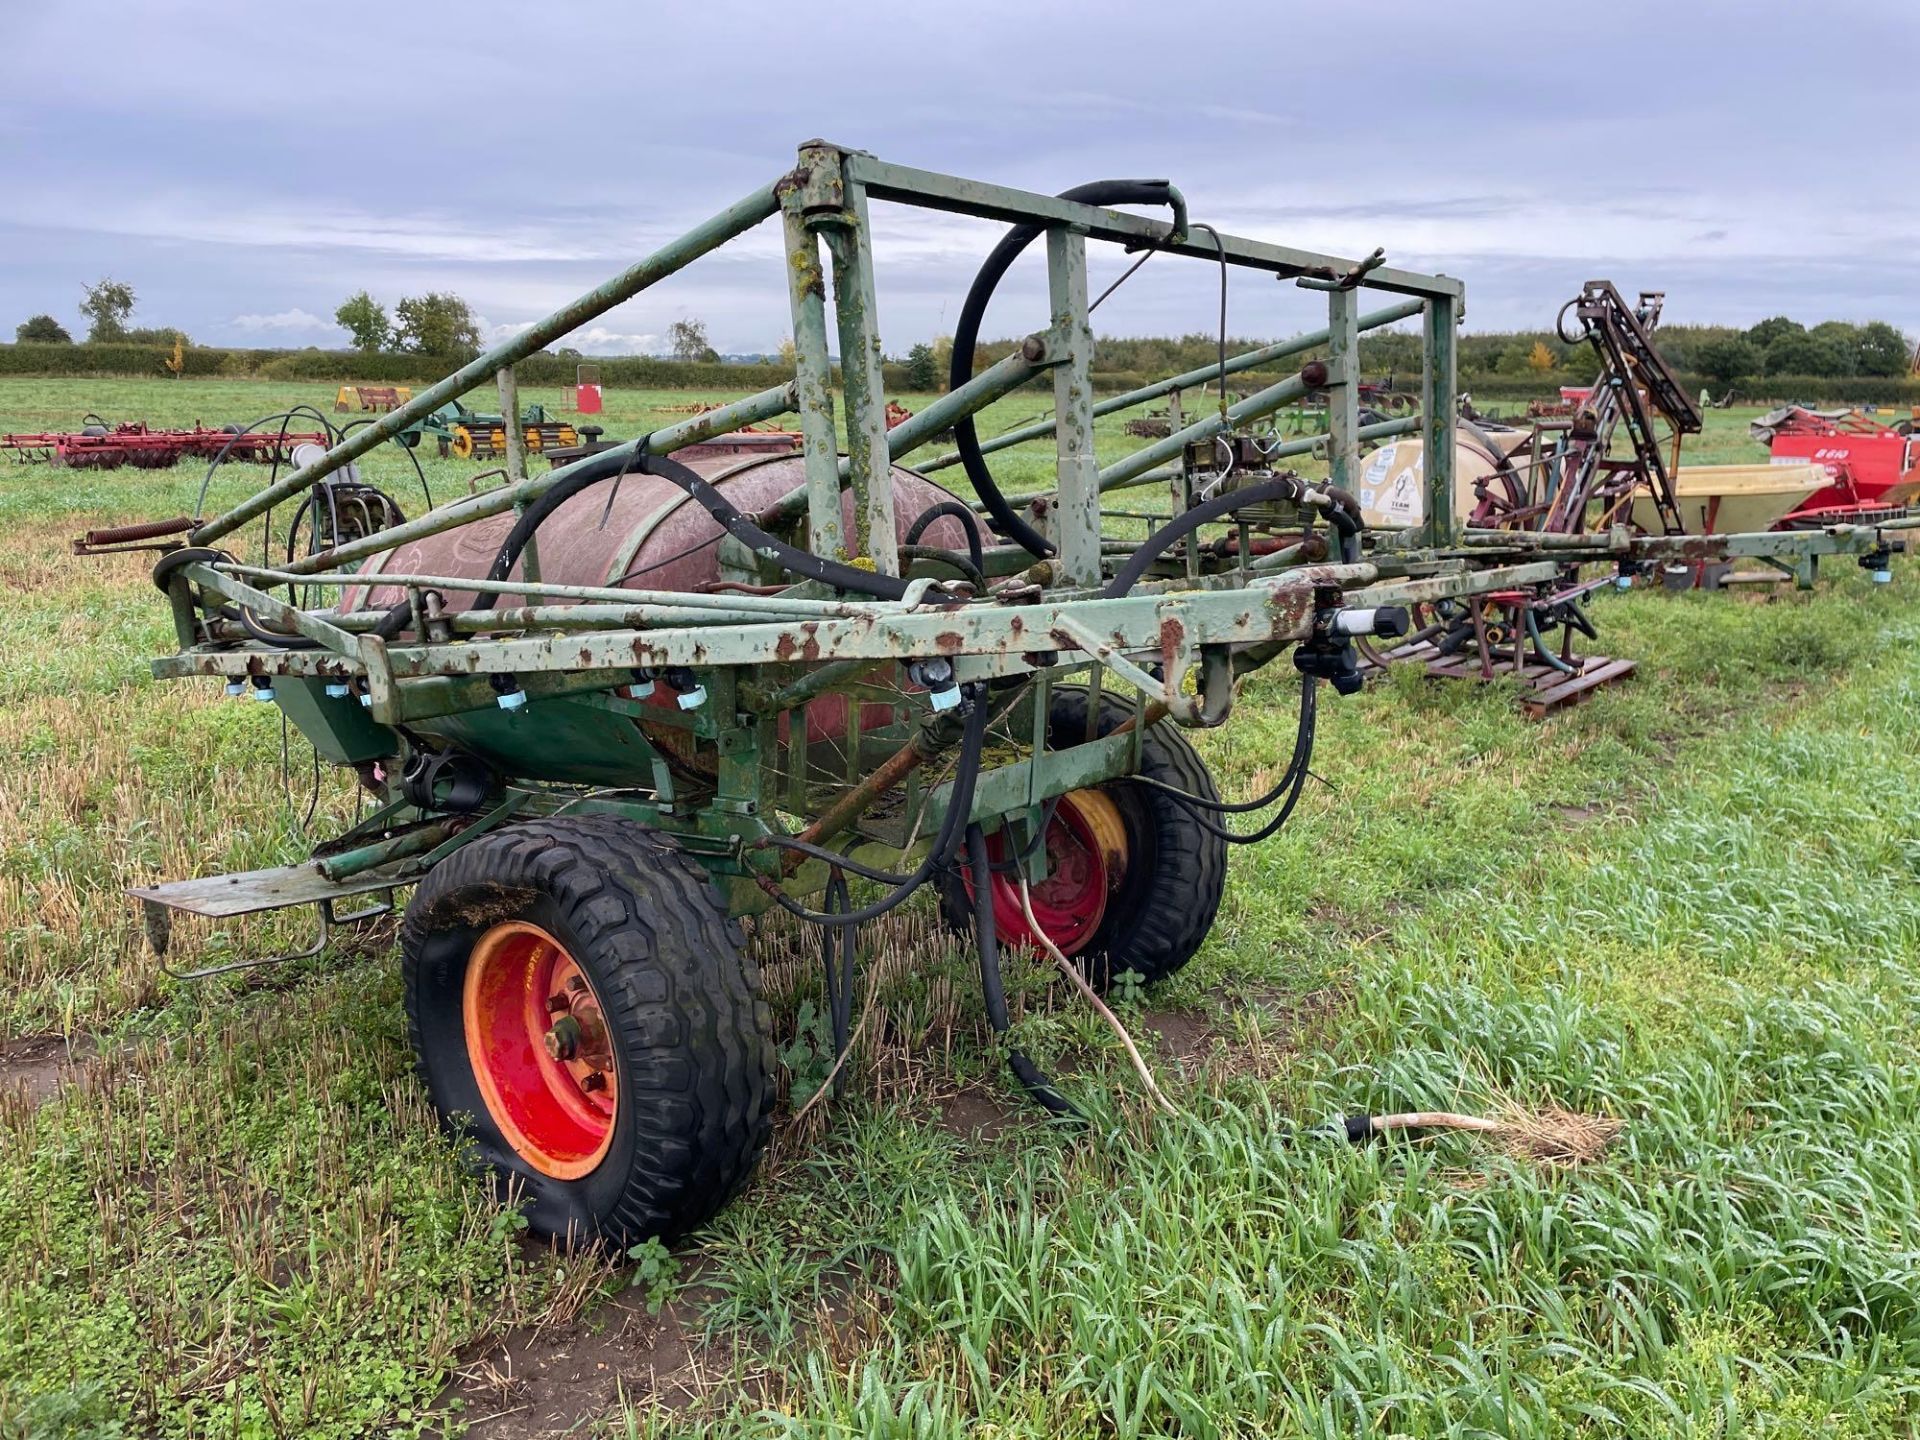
0,344 -> 1920,405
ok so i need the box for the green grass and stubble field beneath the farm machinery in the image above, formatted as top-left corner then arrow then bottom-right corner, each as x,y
0,380 -> 1920,1440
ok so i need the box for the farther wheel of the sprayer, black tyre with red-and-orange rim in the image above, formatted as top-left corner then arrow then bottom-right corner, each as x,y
941,685 -> 1227,991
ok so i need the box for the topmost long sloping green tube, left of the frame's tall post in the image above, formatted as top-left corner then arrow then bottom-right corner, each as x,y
188,184 -> 780,545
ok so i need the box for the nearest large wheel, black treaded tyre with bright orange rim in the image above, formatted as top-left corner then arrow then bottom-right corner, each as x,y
401,816 -> 774,1248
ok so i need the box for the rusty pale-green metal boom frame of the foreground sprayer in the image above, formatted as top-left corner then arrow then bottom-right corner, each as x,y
116,140 -> 1904,936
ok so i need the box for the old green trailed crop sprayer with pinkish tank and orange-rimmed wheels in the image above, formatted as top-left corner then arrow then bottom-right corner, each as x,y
74,142 -> 1904,1244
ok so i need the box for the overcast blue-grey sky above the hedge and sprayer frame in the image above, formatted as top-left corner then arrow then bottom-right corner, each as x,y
0,0 -> 1920,351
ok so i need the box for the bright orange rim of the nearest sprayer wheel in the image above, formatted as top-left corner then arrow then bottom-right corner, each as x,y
461,920 -> 620,1181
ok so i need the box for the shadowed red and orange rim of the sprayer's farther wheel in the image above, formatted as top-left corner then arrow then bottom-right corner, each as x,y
966,789 -> 1127,954
